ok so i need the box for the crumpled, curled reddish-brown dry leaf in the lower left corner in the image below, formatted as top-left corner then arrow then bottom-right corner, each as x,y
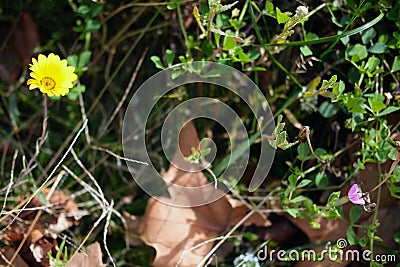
0,189 -> 80,267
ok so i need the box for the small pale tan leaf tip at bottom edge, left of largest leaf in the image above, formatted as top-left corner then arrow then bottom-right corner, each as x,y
66,242 -> 106,267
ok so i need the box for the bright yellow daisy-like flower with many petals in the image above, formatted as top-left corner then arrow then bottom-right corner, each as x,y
28,53 -> 78,96
